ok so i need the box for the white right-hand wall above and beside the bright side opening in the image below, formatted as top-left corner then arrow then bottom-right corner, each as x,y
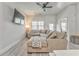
57,5 -> 76,35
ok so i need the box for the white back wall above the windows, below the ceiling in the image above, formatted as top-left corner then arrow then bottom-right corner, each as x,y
32,15 -> 56,28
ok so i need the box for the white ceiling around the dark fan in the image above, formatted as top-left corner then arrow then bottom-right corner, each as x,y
6,2 -> 75,15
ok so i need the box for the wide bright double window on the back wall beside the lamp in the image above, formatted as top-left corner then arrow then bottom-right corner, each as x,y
32,21 -> 44,30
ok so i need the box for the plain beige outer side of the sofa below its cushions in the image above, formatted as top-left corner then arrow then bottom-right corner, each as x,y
48,39 -> 67,51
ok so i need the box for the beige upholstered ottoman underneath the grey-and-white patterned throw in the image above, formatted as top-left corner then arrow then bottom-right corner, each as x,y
27,40 -> 49,53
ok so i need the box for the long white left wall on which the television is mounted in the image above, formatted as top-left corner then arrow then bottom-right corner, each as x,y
0,3 -> 25,49
